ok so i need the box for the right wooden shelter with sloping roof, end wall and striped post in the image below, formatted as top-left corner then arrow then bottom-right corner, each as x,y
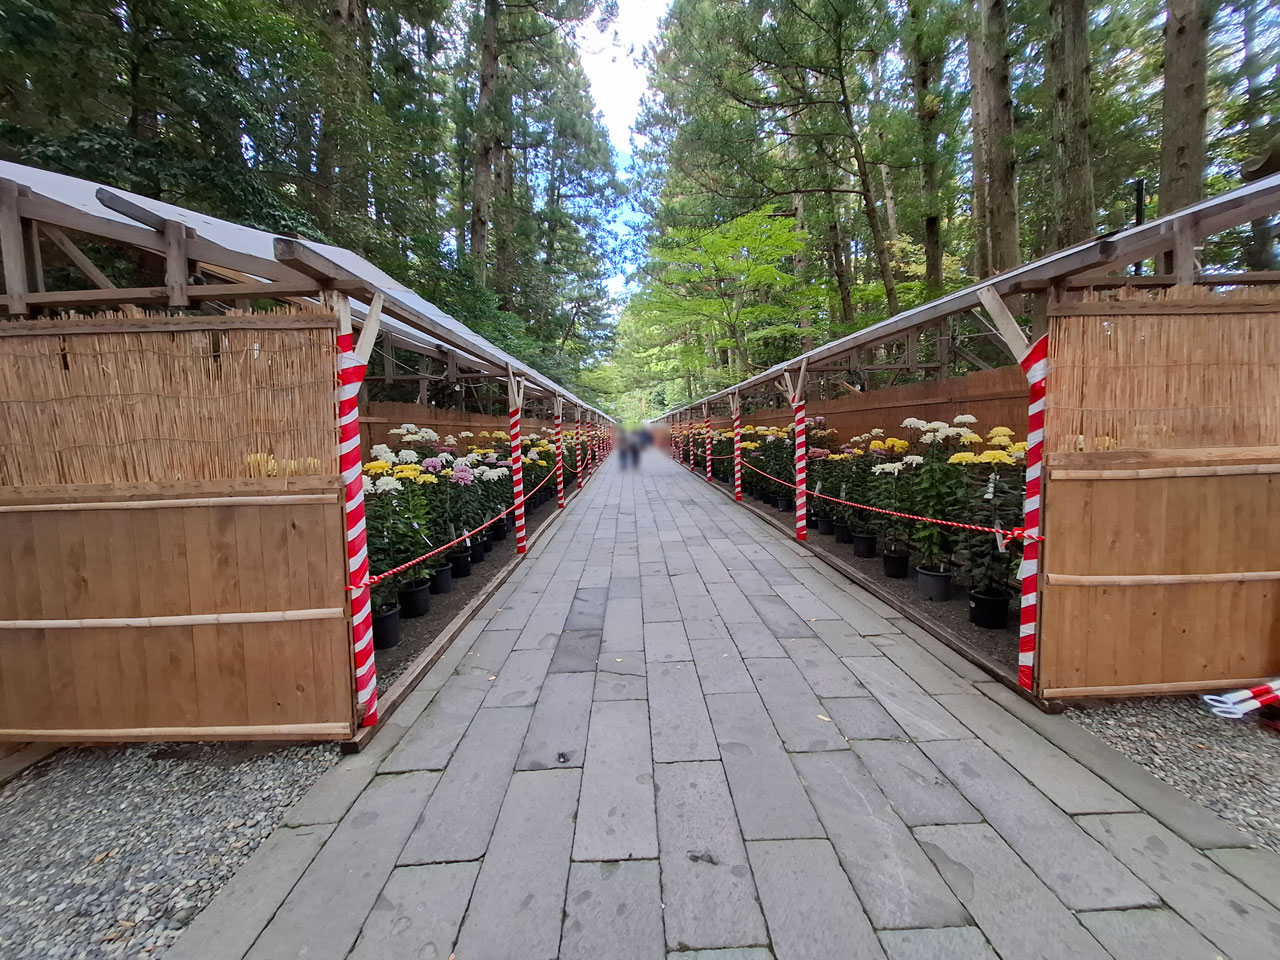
662,174 -> 1280,698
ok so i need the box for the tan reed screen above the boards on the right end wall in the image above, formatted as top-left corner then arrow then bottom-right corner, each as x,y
1046,289 -> 1280,453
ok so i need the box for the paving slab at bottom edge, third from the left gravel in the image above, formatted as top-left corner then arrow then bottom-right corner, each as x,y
349,863 -> 480,960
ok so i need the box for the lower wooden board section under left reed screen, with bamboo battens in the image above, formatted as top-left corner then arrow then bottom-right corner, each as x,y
0,481 -> 355,741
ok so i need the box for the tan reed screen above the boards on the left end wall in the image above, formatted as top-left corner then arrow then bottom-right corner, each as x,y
0,314 -> 338,486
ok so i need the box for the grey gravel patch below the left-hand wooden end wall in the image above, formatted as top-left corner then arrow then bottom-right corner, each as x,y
0,744 -> 339,960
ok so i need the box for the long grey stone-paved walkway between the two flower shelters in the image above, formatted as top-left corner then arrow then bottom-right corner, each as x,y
168,453 -> 1280,960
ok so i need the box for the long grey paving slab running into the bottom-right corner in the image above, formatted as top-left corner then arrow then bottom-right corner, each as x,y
1078,813 -> 1280,960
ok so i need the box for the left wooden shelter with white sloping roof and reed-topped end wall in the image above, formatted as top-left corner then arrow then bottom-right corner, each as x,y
0,163 -> 608,741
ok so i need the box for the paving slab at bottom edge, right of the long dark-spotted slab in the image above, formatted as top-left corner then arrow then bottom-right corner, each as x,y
746,840 -> 884,960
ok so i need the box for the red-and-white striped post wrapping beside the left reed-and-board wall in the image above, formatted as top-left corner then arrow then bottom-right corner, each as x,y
338,333 -> 378,727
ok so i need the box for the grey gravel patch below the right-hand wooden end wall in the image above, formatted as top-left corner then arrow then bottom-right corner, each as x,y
1068,696 -> 1280,852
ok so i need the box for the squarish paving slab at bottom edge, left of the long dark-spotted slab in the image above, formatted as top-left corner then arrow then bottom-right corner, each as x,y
559,860 -> 666,960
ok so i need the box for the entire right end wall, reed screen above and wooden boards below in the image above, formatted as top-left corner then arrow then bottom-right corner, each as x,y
1037,293 -> 1280,698
